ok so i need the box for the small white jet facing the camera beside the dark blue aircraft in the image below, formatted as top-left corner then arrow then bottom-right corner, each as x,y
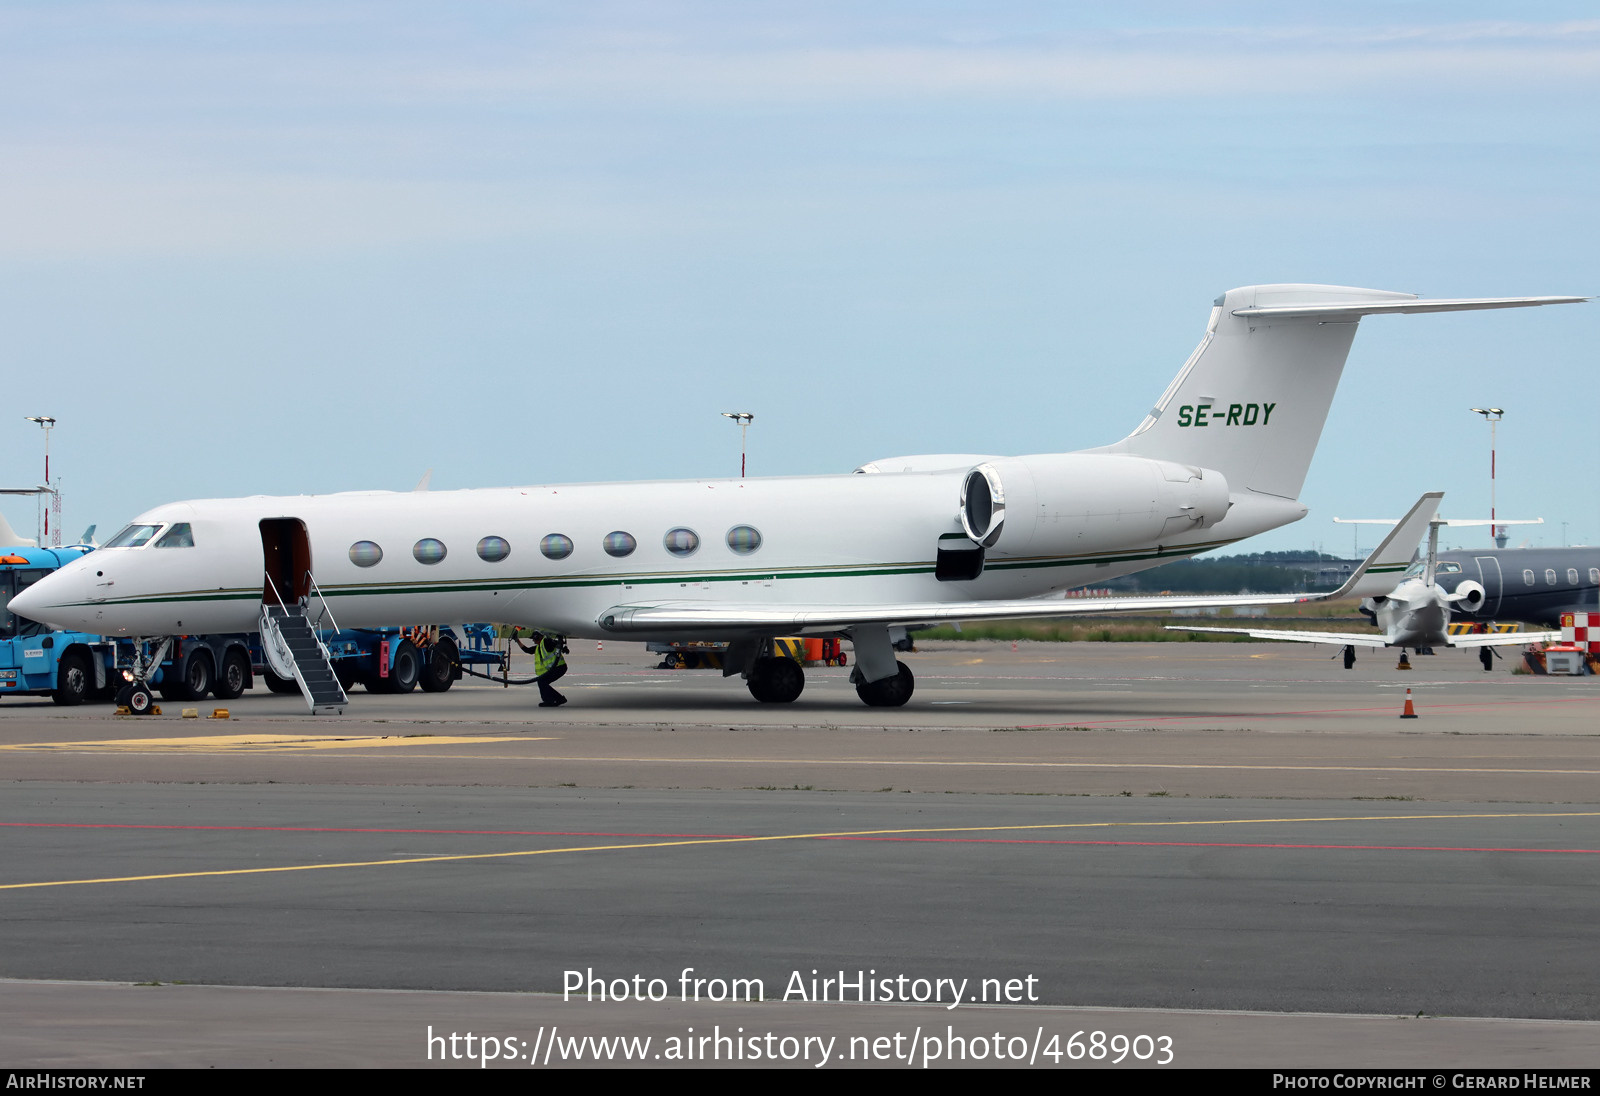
1168,491 -> 1562,669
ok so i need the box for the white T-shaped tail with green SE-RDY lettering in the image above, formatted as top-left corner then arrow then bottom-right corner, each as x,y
1091,285 -> 1586,499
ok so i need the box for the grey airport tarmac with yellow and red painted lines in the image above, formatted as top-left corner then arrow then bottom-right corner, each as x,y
0,642 -> 1600,1070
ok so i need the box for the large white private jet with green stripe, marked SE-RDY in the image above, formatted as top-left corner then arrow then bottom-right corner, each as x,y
11,285 -> 1584,706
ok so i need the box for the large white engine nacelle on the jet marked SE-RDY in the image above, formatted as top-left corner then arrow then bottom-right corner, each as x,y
958,453 -> 1232,555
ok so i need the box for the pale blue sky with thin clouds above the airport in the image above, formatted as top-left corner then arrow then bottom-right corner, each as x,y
0,0 -> 1600,554
